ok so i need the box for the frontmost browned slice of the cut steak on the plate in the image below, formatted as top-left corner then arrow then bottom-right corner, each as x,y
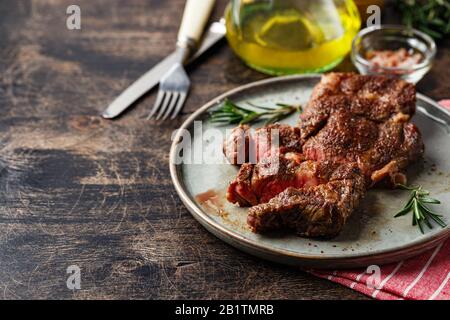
247,164 -> 365,237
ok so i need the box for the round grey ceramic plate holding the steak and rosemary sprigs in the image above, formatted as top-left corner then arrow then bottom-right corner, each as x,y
170,75 -> 450,268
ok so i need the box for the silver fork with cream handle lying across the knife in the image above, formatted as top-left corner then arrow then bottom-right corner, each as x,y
147,0 -> 215,120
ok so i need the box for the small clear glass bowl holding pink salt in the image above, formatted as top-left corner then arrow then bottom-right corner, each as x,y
352,25 -> 436,83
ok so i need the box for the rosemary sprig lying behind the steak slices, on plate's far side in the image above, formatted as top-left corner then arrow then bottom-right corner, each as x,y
210,99 -> 301,124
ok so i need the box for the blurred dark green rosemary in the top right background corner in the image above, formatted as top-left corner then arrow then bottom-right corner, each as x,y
397,0 -> 450,39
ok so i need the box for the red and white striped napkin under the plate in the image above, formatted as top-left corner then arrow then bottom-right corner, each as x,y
310,100 -> 450,300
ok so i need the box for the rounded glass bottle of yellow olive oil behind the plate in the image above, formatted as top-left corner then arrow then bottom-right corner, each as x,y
226,0 -> 361,75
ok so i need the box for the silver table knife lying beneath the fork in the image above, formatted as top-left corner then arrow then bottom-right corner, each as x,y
102,18 -> 226,119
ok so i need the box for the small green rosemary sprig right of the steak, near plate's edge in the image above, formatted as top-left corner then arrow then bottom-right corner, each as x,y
395,184 -> 447,233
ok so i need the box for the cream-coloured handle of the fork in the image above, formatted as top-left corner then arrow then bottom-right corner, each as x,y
178,0 -> 216,47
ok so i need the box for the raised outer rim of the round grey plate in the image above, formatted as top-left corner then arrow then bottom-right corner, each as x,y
169,74 -> 450,267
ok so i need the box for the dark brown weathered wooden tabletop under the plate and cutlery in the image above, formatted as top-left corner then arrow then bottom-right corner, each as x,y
0,0 -> 450,299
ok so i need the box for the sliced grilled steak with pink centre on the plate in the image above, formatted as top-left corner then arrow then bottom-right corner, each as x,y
227,73 -> 424,237
